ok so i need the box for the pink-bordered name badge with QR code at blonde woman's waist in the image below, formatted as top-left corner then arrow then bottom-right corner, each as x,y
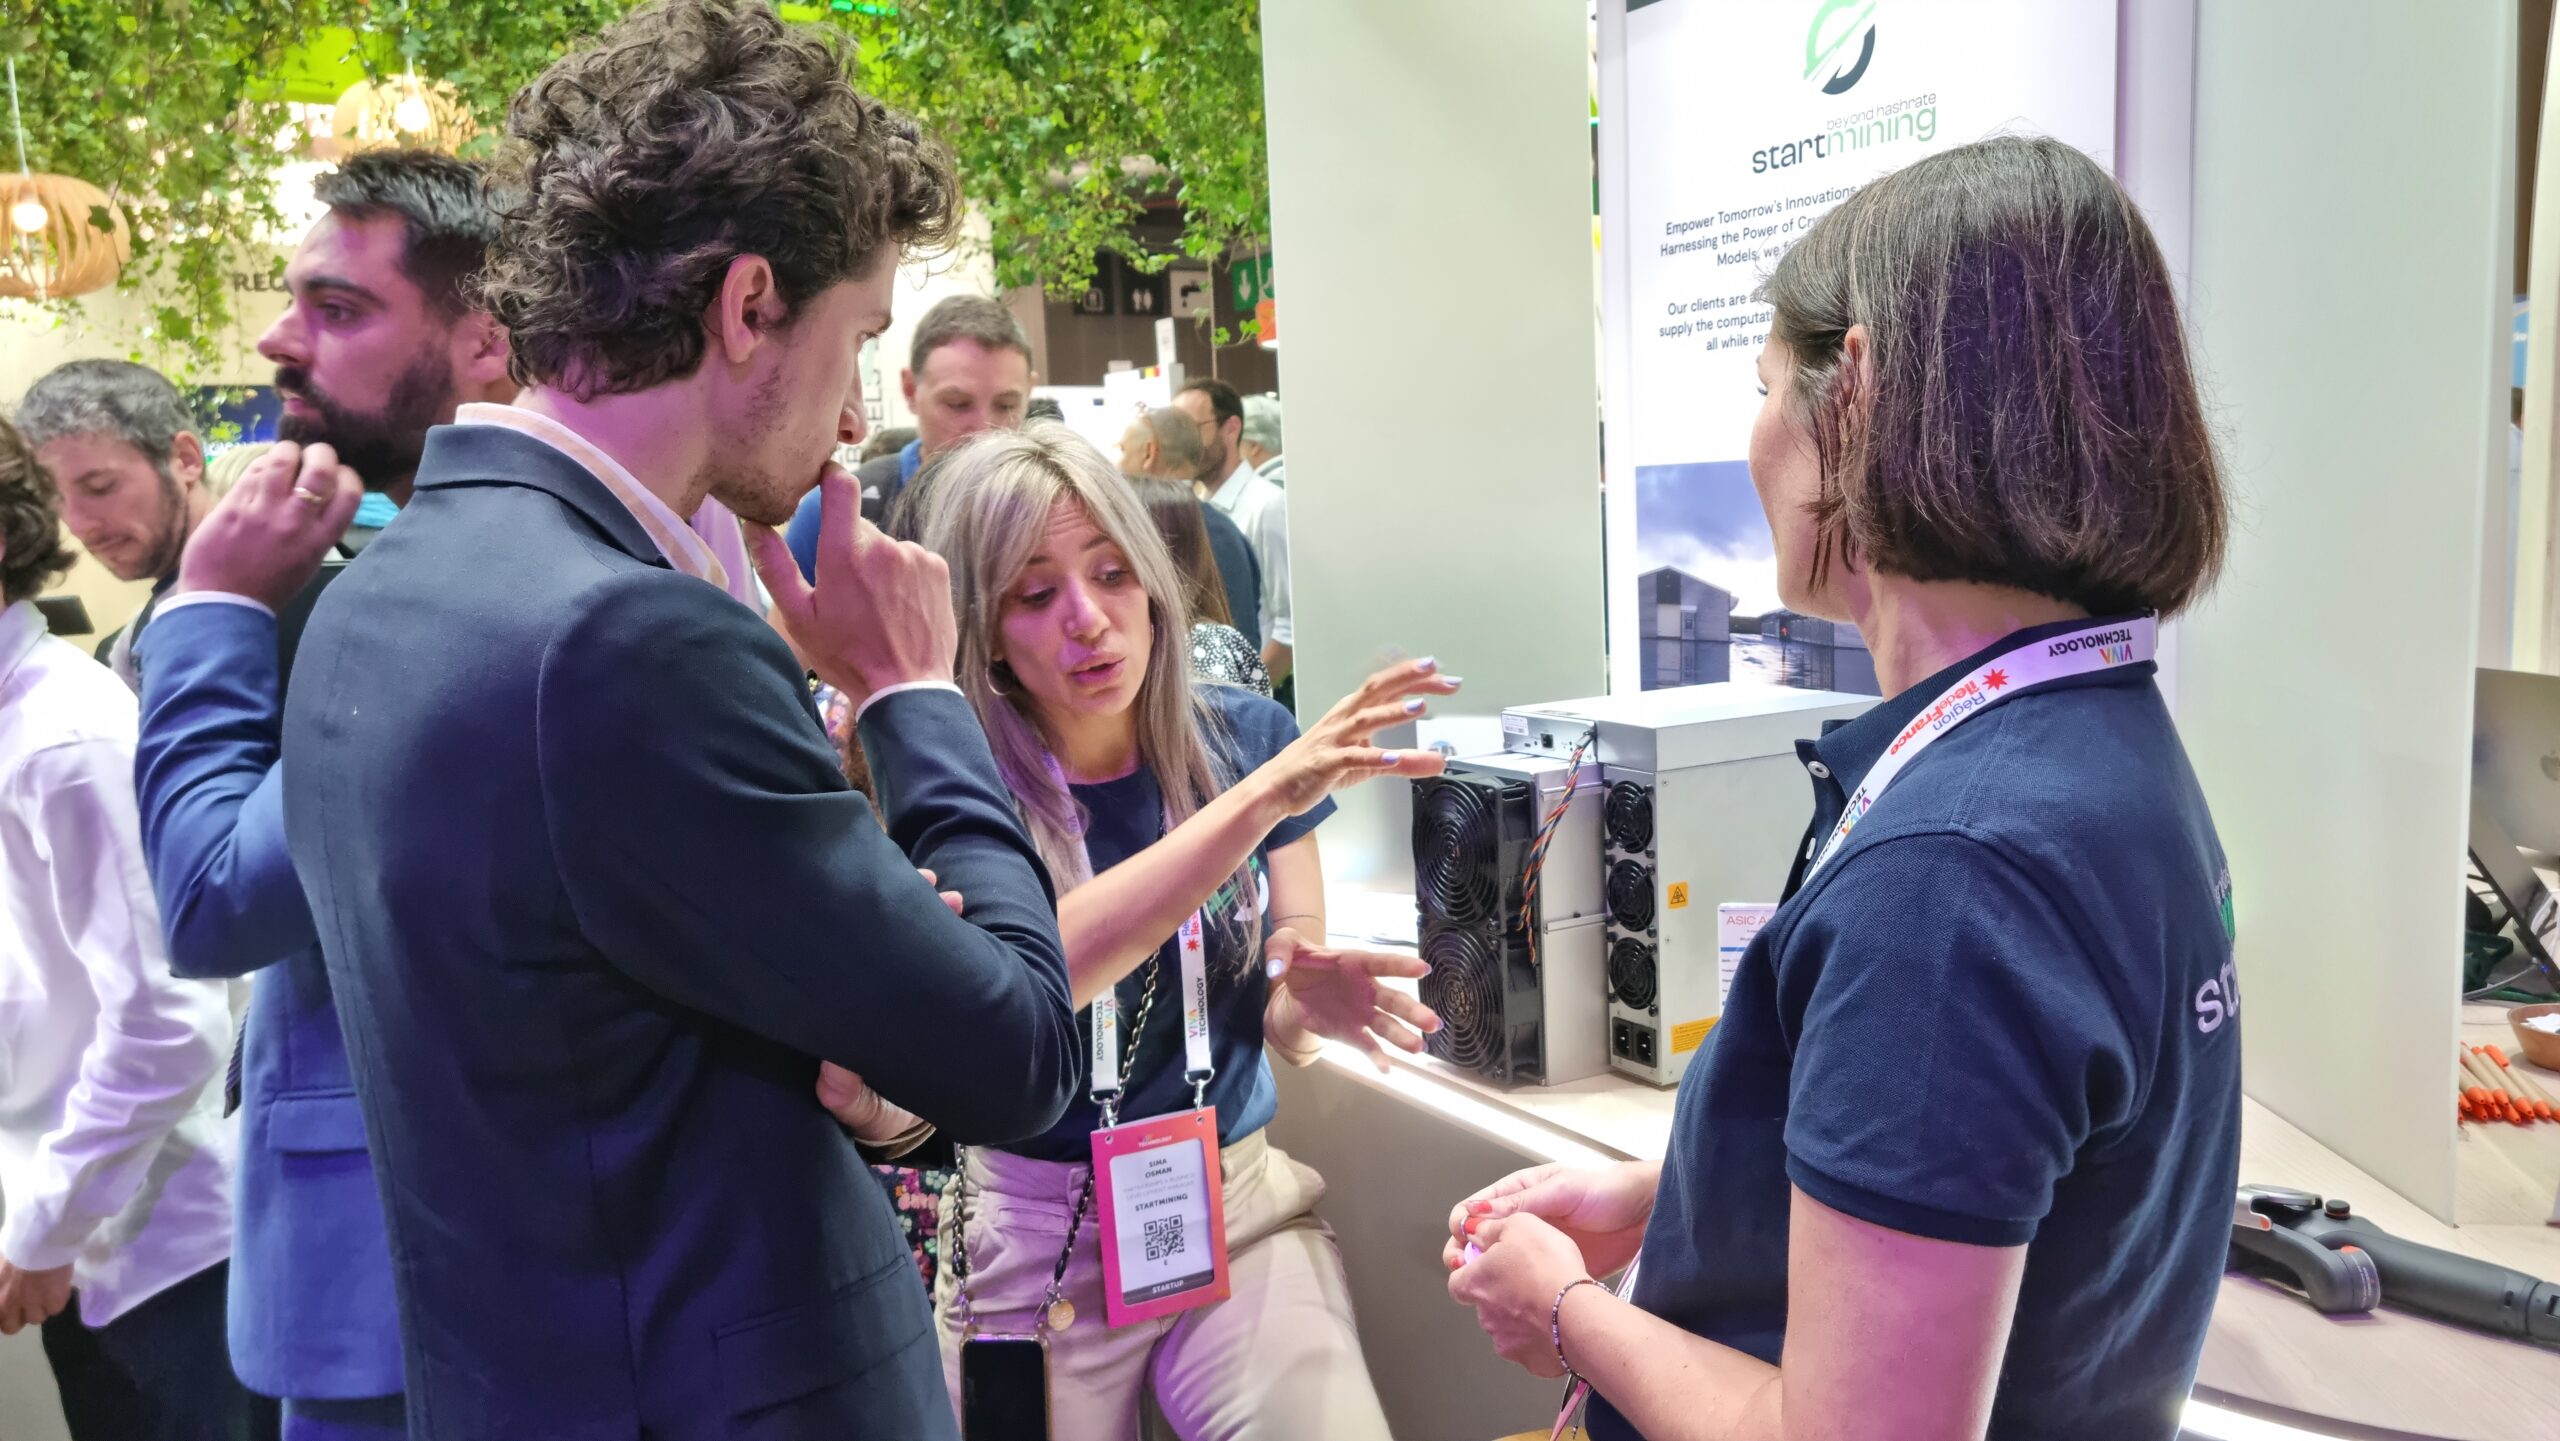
1093,1106 -> 1226,1326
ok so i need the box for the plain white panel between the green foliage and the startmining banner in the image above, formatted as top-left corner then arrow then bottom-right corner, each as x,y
1262,0 -> 1605,880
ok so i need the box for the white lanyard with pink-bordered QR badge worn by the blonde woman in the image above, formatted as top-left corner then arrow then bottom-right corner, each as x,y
1093,911 -> 1233,1326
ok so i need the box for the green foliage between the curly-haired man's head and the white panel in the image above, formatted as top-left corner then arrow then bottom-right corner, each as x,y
845,0 -> 1270,294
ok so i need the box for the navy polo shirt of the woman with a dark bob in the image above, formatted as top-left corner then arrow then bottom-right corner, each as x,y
1590,622 -> 2240,1441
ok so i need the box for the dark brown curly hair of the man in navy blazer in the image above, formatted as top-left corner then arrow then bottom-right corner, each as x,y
481,0 -> 960,399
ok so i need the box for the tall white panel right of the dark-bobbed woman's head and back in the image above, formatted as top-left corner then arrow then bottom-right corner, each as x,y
2170,0 -> 2516,1221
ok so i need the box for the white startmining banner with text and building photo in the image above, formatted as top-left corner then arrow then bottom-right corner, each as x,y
1600,0 -> 2117,694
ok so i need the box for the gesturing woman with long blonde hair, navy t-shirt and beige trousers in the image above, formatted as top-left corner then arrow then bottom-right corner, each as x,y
834,425 -> 1457,1441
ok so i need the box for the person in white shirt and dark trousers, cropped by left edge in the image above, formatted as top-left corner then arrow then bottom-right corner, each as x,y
0,412 -> 259,1441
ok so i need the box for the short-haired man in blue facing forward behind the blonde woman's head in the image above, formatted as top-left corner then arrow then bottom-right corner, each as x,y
788,294 -> 1032,563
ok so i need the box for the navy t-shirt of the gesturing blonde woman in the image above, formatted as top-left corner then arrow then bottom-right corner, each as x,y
1004,683 -> 1334,1162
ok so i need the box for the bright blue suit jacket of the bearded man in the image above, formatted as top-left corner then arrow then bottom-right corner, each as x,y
136,604 -> 399,1400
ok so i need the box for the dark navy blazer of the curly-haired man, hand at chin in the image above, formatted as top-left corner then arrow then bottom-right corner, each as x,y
284,425 -> 1078,1441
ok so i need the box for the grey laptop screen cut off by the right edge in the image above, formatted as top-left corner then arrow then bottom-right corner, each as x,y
2470,668 -> 2560,988
